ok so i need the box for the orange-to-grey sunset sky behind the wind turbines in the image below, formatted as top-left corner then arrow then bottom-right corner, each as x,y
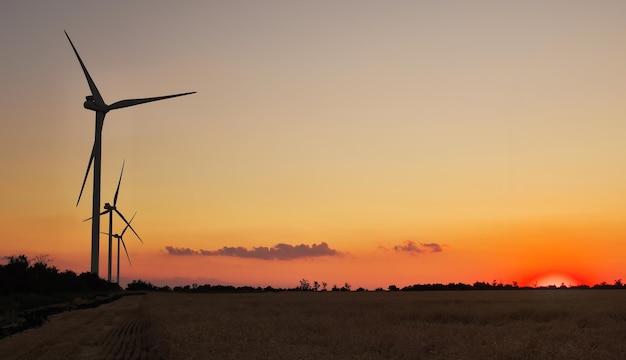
0,0 -> 626,289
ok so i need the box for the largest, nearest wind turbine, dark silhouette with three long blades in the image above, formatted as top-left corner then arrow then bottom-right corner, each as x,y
65,31 -> 195,274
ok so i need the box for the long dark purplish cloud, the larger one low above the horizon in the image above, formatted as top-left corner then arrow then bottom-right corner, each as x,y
165,242 -> 342,260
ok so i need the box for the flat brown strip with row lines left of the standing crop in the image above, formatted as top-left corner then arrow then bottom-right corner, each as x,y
0,295 -> 167,359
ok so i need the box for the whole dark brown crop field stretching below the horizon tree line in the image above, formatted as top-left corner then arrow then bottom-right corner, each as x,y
0,290 -> 626,359
